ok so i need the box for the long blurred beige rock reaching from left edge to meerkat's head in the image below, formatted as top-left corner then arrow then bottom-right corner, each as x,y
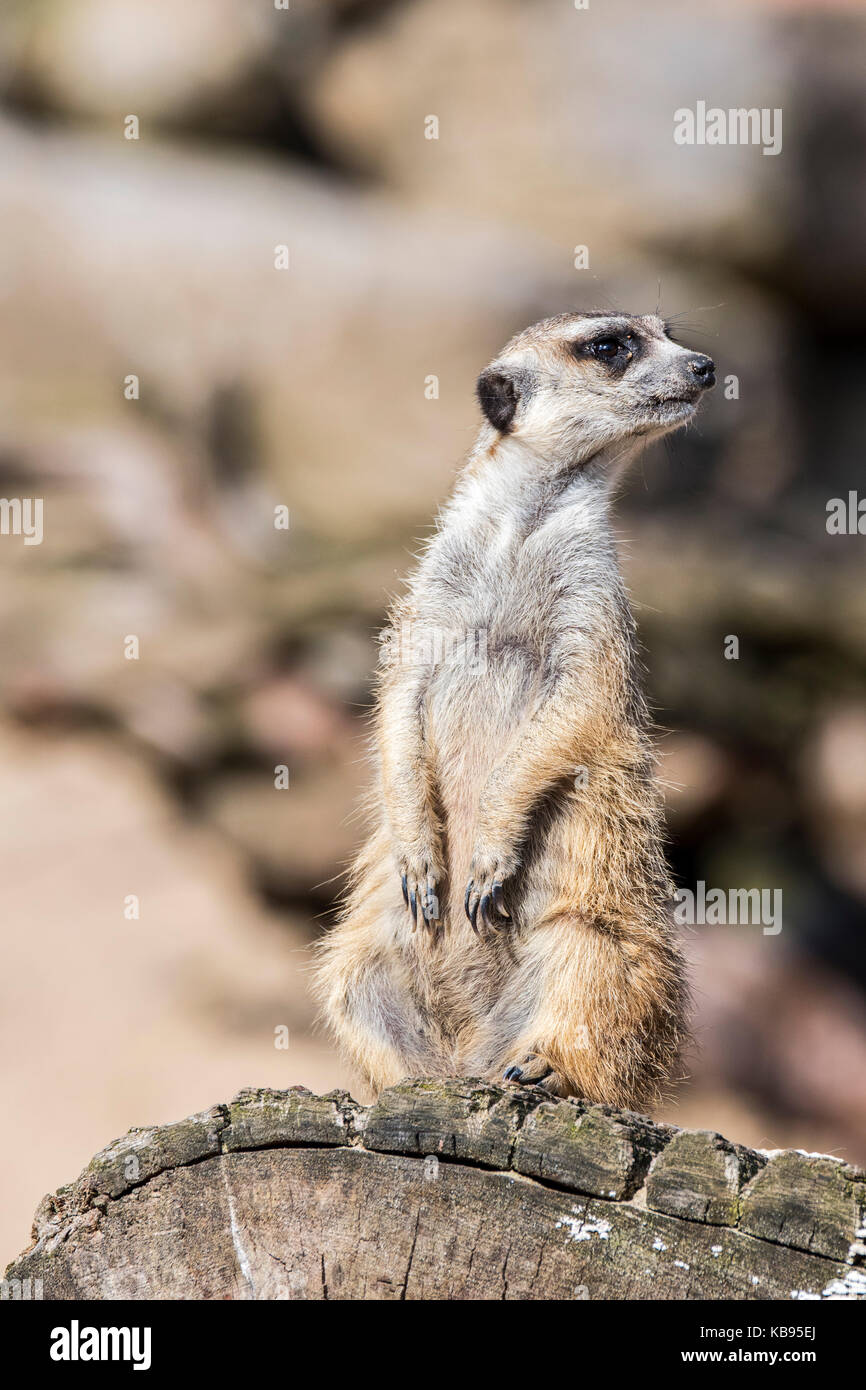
0,113 -> 575,535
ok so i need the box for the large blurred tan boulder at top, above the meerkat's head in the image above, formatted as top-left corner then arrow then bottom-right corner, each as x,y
314,0 -> 787,258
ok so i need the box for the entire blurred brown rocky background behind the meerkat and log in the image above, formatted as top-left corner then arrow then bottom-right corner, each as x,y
0,0 -> 866,1257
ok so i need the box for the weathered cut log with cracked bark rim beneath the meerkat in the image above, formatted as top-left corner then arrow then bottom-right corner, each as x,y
4,1080 -> 866,1300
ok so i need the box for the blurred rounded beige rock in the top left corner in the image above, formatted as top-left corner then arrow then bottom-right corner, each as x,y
0,0 -> 338,145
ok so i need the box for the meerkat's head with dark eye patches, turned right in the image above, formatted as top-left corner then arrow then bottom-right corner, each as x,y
477,313 -> 716,466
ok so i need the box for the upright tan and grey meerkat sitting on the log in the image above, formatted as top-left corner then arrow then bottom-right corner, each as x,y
316,313 -> 714,1109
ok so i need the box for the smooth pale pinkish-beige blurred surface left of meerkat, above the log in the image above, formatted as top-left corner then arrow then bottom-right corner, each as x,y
0,726 -> 348,1252
